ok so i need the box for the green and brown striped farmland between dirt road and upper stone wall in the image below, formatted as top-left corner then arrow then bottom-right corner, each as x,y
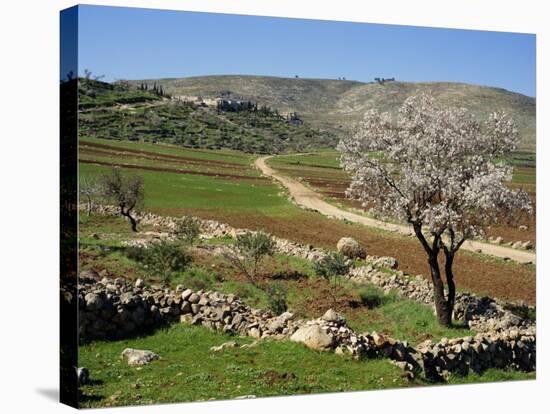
79,138 -> 536,303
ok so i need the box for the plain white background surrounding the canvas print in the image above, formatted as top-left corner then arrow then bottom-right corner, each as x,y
0,0 -> 550,414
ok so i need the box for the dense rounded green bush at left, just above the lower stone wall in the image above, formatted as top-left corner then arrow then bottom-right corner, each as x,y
141,240 -> 193,285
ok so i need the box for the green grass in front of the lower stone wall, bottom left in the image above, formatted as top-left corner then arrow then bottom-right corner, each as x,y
79,324 -> 409,407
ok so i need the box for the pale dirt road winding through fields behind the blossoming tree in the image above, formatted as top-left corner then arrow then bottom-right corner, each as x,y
254,155 -> 535,263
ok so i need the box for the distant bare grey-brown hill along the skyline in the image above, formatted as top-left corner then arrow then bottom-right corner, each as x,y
130,75 -> 536,150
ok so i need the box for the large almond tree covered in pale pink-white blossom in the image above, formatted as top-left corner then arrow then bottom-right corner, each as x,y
338,94 -> 531,326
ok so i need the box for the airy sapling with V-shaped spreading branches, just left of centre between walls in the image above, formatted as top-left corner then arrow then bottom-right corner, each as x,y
225,231 -> 275,288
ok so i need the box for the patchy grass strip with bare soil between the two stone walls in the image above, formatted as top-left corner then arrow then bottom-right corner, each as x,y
80,215 -> 472,344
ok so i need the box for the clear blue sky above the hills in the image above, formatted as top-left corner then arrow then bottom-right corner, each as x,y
70,6 -> 536,96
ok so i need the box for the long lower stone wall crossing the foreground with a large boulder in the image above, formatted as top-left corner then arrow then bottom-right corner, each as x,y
78,271 -> 536,379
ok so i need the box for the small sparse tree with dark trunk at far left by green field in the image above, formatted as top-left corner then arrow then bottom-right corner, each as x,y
101,168 -> 144,231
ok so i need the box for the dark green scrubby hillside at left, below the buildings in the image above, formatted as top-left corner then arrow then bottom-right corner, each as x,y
79,79 -> 337,153
